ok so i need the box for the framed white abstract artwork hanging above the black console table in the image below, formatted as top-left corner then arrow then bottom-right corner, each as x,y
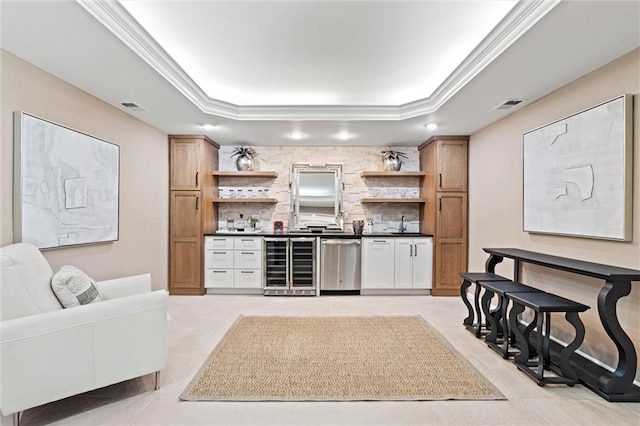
523,95 -> 633,241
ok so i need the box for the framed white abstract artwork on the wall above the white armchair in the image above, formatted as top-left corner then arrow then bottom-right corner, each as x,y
14,112 -> 120,248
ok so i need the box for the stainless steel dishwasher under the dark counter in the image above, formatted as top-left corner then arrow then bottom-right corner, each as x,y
320,238 -> 361,291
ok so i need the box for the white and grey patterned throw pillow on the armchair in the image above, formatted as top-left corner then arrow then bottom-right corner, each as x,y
51,265 -> 102,308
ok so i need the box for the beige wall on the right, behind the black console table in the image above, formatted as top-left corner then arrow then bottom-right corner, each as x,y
469,49 -> 640,378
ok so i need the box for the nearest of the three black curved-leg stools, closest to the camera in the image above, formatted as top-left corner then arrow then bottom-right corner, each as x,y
506,292 -> 589,386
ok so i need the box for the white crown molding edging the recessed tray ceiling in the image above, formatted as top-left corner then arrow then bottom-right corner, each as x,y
76,0 -> 561,121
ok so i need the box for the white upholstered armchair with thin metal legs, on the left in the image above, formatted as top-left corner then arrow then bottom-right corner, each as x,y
0,243 -> 168,424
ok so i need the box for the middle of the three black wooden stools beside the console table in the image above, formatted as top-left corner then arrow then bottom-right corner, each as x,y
477,281 -> 542,359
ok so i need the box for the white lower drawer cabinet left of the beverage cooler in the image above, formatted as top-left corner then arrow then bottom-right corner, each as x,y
204,236 -> 262,289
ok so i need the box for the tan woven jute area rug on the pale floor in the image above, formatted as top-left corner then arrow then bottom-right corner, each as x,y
180,316 -> 506,401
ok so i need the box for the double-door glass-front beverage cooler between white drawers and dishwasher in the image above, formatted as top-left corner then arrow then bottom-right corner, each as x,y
264,237 -> 317,296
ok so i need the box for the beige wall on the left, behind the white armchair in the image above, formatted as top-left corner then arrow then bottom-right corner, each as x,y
0,50 -> 169,289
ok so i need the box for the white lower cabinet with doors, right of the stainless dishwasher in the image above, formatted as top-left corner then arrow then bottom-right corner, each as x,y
362,237 -> 433,290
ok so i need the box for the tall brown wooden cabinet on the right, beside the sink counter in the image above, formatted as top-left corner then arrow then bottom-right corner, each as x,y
419,136 -> 469,296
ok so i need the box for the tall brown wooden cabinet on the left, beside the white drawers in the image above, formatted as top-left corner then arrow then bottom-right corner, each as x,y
169,135 -> 220,295
